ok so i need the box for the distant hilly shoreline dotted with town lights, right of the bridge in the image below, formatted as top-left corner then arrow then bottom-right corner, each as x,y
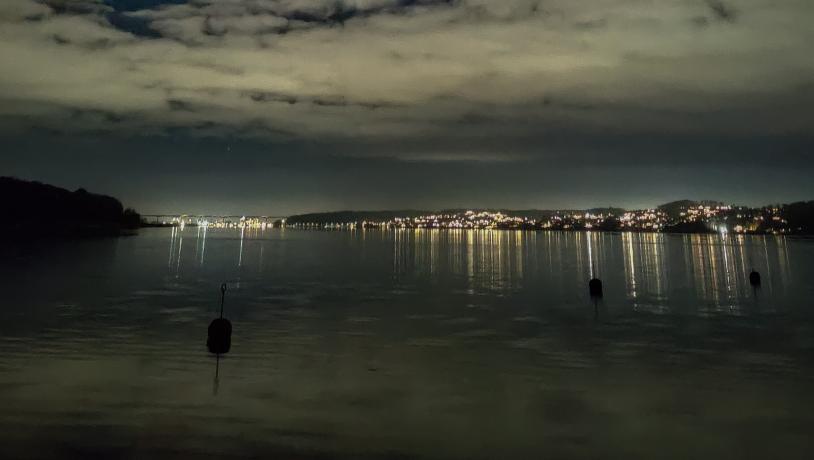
276,200 -> 814,235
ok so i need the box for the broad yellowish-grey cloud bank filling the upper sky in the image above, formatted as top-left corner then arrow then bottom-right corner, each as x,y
0,0 -> 814,161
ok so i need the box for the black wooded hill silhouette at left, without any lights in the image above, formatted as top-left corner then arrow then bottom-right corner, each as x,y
0,177 -> 141,235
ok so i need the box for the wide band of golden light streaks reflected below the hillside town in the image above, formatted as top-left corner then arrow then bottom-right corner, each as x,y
384,230 -> 810,313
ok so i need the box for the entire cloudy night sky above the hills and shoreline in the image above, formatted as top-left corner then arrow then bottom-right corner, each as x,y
0,0 -> 814,215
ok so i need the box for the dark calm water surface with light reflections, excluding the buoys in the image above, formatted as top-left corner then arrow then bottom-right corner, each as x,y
0,228 -> 814,459
